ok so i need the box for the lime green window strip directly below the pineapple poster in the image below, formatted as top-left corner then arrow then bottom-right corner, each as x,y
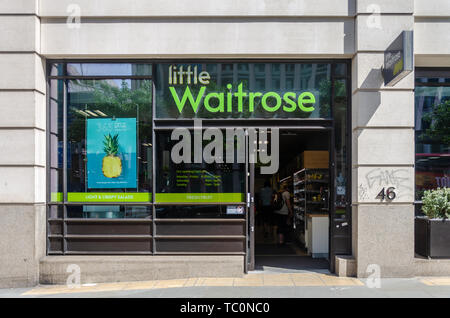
67,192 -> 151,202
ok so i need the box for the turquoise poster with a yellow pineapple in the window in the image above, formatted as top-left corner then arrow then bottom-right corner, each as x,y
86,118 -> 137,189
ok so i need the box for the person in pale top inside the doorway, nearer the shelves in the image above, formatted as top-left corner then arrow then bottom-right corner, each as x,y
273,184 -> 293,245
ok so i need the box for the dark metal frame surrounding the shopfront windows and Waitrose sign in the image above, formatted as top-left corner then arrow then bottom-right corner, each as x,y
46,59 -> 352,255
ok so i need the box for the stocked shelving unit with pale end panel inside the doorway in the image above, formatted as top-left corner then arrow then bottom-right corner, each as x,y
292,168 -> 330,257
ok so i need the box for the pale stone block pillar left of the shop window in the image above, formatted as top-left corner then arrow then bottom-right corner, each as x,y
0,0 -> 46,288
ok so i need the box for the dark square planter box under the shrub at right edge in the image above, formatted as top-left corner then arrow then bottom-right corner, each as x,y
414,217 -> 450,258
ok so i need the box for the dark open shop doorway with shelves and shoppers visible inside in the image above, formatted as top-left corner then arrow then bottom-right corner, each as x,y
254,130 -> 332,272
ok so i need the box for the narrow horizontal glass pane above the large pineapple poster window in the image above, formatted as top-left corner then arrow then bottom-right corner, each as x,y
67,63 -> 152,76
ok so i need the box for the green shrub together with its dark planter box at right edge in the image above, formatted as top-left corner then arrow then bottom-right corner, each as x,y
415,188 -> 450,258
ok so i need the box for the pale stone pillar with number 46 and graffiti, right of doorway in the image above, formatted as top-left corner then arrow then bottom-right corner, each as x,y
352,0 -> 414,277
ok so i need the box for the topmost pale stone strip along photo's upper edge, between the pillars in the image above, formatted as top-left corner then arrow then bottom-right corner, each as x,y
37,0 -> 356,18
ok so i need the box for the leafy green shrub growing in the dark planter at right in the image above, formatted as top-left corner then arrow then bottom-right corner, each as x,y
422,188 -> 450,219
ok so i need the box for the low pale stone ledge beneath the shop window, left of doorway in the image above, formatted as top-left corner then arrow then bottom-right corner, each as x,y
39,255 -> 244,284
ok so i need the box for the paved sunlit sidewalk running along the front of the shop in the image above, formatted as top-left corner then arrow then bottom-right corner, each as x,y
0,272 -> 450,298
